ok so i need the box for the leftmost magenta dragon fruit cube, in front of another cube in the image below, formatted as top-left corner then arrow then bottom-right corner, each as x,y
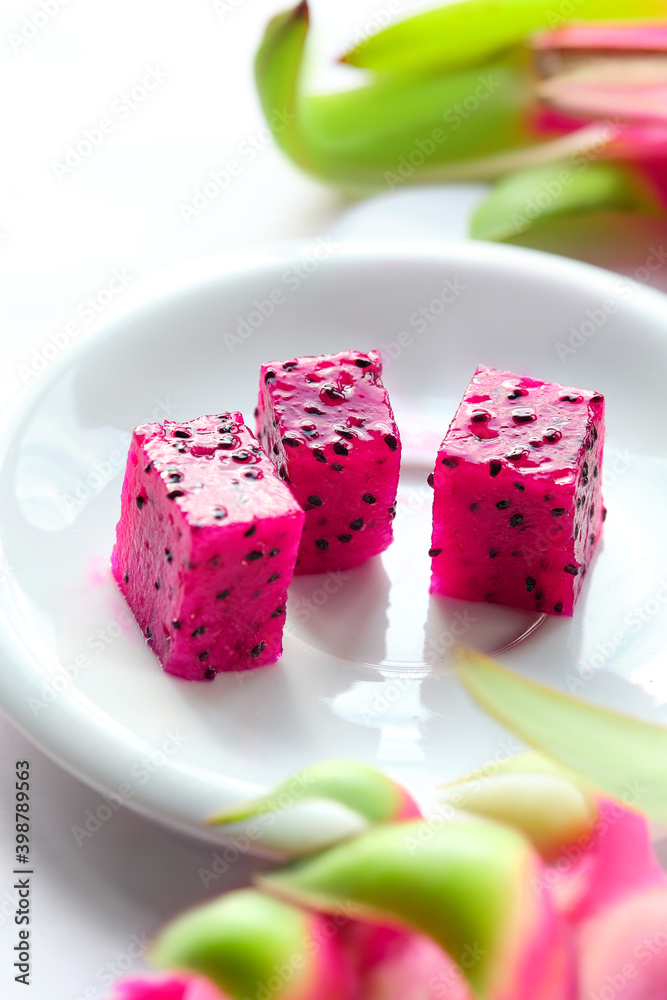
112,413 -> 304,680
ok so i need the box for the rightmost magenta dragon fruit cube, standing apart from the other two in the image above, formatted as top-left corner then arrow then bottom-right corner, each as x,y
430,367 -> 606,615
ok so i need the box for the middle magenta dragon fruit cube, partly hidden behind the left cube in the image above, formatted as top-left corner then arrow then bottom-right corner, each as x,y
257,351 -> 401,573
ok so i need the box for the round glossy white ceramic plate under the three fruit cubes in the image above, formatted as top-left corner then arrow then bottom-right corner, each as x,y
0,243 -> 667,849
